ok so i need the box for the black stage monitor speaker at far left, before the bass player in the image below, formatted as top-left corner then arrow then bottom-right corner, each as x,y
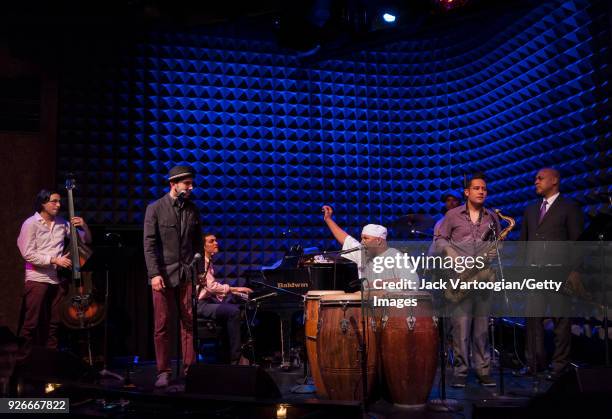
15,346 -> 99,383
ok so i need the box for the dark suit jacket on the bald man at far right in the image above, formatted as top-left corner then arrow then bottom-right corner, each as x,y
520,195 -> 584,265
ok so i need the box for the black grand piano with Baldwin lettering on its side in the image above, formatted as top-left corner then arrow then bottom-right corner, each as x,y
244,246 -> 359,369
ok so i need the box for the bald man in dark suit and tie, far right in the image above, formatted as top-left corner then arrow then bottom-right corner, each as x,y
520,168 -> 584,380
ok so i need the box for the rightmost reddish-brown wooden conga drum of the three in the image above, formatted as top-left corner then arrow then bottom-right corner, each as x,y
380,291 -> 439,407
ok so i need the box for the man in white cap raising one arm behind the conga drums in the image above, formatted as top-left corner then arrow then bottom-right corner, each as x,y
322,205 -> 419,291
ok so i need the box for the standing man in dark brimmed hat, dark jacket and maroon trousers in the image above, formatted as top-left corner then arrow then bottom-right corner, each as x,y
144,166 -> 203,387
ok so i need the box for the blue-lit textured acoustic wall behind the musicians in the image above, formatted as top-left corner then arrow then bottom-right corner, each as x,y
58,0 -> 611,277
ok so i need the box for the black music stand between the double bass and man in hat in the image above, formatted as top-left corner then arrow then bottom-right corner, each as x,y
81,243 -> 124,380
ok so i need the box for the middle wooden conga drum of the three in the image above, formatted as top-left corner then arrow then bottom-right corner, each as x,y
317,293 -> 378,400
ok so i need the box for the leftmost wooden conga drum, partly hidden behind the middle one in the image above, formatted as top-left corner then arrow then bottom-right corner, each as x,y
304,290 -> 344,399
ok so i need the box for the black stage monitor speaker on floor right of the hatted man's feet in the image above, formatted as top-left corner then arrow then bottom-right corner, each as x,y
185,364 -> 281,398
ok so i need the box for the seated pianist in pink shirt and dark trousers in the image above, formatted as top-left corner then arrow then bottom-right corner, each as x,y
198,233 -> 253,364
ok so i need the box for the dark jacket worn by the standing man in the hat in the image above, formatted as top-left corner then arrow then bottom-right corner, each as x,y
143,194 -> 204,287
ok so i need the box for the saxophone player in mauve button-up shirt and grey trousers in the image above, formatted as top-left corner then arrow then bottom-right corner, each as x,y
434,174 -> 500,388
